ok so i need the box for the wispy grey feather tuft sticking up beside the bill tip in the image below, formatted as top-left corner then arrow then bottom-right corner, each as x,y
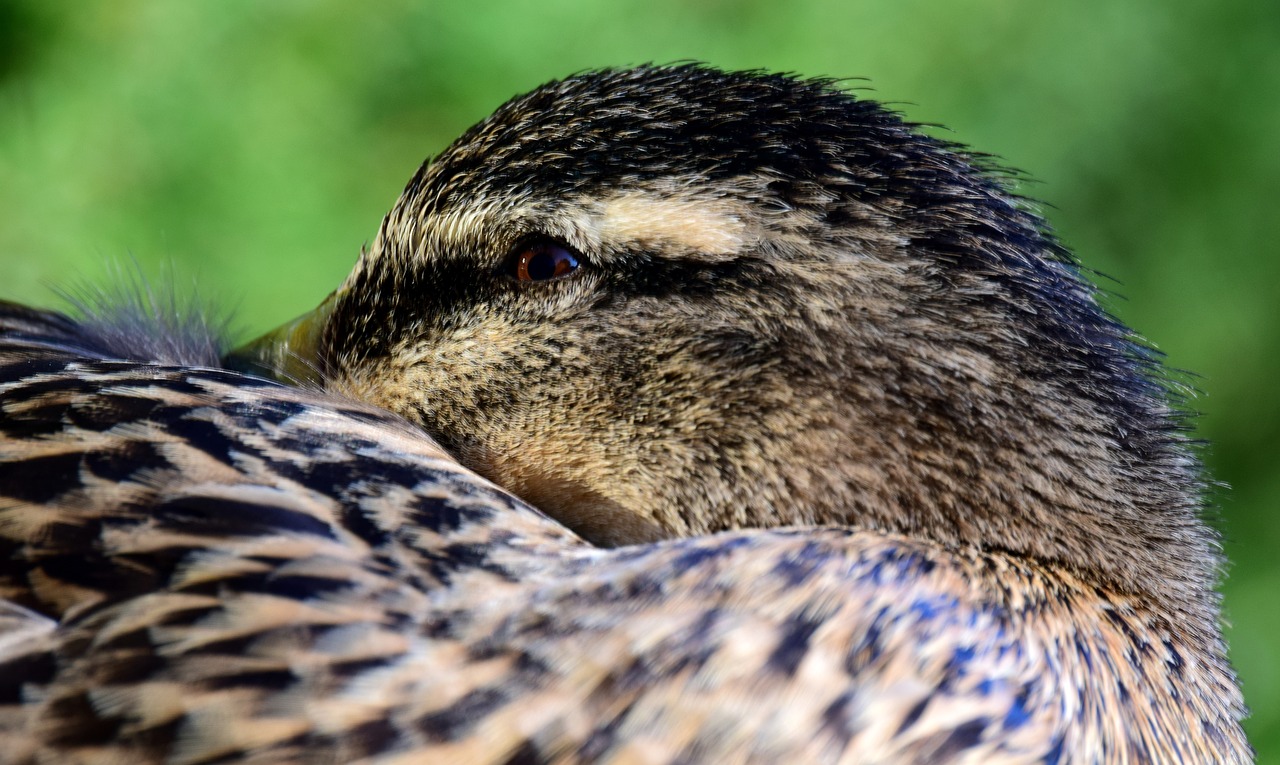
55,262 -> 230,367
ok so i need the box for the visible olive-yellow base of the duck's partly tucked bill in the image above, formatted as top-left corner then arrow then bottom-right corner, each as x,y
223,290 -> 342,386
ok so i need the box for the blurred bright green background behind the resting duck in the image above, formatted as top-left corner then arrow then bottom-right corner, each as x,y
0,0 -> 1280,761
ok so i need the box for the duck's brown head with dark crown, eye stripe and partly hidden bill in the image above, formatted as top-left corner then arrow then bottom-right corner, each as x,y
234,65 -> 1219,622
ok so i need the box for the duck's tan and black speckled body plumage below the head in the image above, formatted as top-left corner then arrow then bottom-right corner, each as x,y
0,315 -> 1240,762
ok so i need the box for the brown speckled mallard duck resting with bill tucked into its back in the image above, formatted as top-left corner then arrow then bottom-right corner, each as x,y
0,65 -> 1252,764
